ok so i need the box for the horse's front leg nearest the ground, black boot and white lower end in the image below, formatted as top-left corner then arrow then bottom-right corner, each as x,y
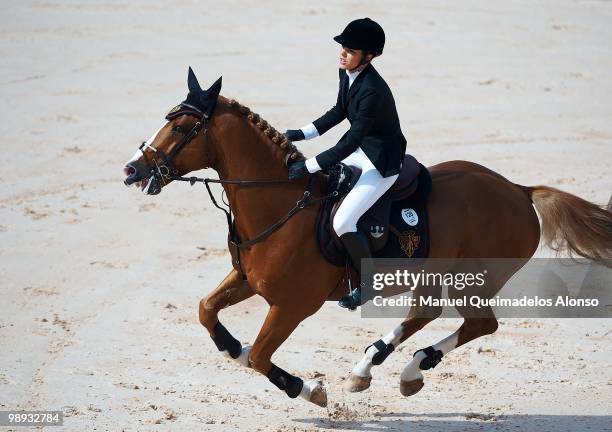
249,305 -> 327,407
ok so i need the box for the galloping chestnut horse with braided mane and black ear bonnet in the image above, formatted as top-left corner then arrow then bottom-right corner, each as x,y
124,68 -> 612,407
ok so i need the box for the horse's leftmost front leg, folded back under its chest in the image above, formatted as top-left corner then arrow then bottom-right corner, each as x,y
199,269 -> 254,366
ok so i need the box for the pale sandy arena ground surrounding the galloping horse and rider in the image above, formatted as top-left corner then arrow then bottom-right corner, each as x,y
0,0 -> 612,431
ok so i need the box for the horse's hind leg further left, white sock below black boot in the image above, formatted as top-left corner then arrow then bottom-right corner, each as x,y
344,287 -> 442,392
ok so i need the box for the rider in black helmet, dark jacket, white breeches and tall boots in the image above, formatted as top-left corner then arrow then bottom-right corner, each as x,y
285,18 -> 406,310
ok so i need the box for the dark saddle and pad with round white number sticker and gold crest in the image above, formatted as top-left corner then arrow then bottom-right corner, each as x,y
316,155 -> 432,267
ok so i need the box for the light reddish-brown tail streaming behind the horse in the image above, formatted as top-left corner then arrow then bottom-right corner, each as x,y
517,185 -> 612,267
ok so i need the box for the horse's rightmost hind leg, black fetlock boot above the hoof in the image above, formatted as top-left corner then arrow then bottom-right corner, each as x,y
400,306 -> 498,396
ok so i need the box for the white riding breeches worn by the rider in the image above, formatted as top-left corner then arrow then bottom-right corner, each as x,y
333,148 -> 399,236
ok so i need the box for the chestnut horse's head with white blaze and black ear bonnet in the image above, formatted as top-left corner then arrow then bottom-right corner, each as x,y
123,67 -> 221,195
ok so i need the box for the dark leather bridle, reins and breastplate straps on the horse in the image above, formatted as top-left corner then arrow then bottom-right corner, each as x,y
139,103 -> 339,251
